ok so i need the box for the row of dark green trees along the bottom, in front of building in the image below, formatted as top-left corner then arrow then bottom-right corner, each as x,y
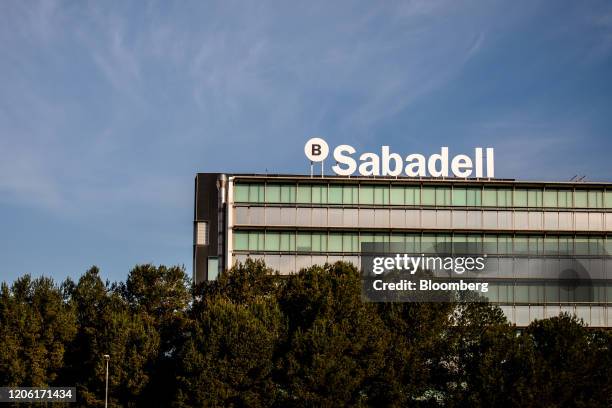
0,259 -> 612,407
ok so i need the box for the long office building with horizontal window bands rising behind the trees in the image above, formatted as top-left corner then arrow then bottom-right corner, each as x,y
193,173 -> 612,327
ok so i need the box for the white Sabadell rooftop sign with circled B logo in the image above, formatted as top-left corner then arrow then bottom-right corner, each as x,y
304,137 -> 495,178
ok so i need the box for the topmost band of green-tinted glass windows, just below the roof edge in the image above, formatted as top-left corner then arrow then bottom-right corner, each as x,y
234,182 -> 612,209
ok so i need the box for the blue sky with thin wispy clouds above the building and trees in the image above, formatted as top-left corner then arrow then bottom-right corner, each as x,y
0,0 -> 612,281
